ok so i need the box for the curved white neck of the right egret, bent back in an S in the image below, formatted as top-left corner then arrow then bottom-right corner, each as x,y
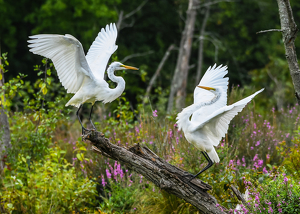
176,89 -> 221,129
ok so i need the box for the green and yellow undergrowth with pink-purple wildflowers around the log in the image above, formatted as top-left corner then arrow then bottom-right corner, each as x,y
0,55 -> 300,214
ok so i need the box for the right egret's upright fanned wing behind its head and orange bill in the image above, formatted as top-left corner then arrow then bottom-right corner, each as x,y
192,64 -> 229,121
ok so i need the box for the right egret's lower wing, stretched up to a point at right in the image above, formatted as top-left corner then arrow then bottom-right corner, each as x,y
191,89 -> 264,146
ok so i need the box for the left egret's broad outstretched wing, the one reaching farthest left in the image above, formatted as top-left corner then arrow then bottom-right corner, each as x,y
28,34 -> 94,93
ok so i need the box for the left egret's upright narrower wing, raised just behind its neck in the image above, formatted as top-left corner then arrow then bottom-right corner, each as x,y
86,24 -> 118,79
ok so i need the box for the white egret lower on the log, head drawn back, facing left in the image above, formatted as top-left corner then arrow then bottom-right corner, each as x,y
176,65 -> 264,180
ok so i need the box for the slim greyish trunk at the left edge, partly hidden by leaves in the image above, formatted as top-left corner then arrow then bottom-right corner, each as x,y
0,47 -> 11,171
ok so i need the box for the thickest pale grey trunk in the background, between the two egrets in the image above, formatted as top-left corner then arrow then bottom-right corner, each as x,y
167,0 -> 197,112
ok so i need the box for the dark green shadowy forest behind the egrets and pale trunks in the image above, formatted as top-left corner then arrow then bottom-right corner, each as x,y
0,0 -> 300,110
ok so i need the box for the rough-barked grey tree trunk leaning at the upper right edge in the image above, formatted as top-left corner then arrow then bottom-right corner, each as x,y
277,0 -> 300,105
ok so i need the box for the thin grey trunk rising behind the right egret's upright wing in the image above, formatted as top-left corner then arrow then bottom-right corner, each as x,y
195,4 -> 210,85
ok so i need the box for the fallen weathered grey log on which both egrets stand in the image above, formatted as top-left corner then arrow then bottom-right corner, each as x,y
84,131 -> 225,214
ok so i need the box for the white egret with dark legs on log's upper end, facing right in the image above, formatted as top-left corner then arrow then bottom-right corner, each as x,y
28,24 -> 138,132
